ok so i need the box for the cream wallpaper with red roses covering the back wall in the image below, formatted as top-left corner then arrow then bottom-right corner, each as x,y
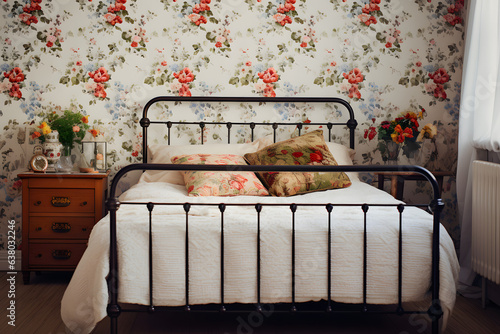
0,0 -> 465,249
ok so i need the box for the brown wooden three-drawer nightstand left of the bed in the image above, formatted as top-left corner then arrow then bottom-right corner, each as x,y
18,172 -> 109,284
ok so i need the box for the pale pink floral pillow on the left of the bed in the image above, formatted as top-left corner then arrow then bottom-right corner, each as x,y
172,154 -> 269,196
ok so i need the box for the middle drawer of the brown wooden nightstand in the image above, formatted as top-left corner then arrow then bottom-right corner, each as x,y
29,216 -> 94,240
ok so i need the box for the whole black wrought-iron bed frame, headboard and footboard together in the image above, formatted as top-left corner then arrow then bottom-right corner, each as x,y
107,96 -> 444,333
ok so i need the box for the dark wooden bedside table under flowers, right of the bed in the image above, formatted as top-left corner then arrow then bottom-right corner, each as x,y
375,171 -> 453,200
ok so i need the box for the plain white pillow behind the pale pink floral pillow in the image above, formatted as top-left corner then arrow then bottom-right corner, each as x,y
139,136 -> 273,185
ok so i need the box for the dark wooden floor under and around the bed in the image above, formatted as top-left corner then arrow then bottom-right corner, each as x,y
0,272 -> 500,334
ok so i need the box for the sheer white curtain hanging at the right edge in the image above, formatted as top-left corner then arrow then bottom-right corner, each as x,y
457,0 -> 500,292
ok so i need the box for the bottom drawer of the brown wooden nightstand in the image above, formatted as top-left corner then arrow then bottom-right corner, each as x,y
29,243 -> 87,267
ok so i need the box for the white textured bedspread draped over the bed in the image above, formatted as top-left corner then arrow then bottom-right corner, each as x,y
61,181 -> 459,333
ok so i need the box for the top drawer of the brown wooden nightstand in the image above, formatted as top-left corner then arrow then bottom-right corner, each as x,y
29,189 -> 94,213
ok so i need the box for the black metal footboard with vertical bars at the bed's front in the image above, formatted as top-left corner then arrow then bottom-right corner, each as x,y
107,164 -> 444,333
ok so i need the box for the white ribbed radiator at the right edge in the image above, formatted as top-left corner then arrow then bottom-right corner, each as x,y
472,160 -> 500,284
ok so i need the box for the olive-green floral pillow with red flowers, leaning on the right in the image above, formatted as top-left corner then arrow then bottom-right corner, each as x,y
245,130 -> 351,196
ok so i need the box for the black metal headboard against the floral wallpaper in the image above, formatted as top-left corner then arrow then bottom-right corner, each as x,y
140,96 -> 358,162
